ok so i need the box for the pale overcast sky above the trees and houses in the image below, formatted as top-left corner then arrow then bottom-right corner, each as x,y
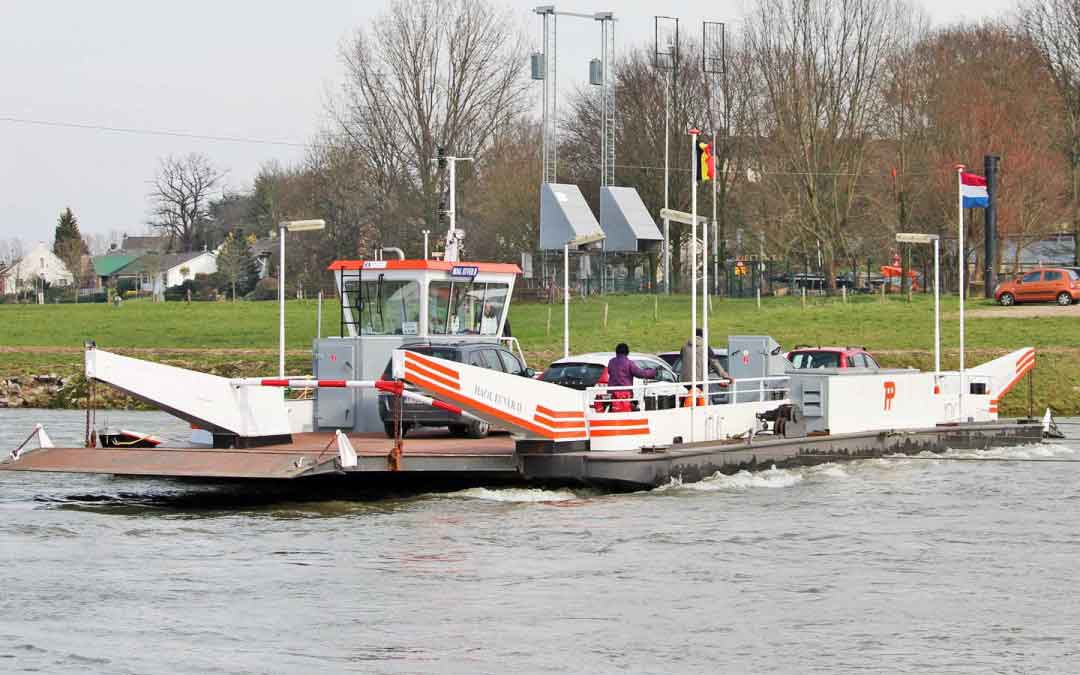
0,0 -> 1015,247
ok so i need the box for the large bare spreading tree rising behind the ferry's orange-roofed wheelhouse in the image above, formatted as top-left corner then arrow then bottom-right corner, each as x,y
332,0 -> 528,251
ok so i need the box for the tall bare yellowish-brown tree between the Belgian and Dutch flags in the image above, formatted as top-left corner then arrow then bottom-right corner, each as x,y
746,0 -> 907,288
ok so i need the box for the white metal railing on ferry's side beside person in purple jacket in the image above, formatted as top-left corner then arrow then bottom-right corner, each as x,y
585,376 -> 791,413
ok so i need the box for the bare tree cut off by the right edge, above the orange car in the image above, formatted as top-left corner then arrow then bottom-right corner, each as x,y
1021,0 -> 1080,265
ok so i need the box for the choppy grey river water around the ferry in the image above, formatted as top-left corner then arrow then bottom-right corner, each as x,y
0,410 -> 1080,673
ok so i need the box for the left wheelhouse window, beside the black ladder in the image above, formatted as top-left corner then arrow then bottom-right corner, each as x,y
345,274 -> 420,335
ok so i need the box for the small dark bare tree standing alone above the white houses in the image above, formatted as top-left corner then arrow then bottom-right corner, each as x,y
150,152 -> 224,251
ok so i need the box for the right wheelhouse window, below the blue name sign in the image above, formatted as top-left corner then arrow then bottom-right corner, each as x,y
428,280 -> 510,336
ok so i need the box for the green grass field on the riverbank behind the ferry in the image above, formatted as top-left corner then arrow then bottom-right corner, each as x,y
0,296 -> 1080,415
